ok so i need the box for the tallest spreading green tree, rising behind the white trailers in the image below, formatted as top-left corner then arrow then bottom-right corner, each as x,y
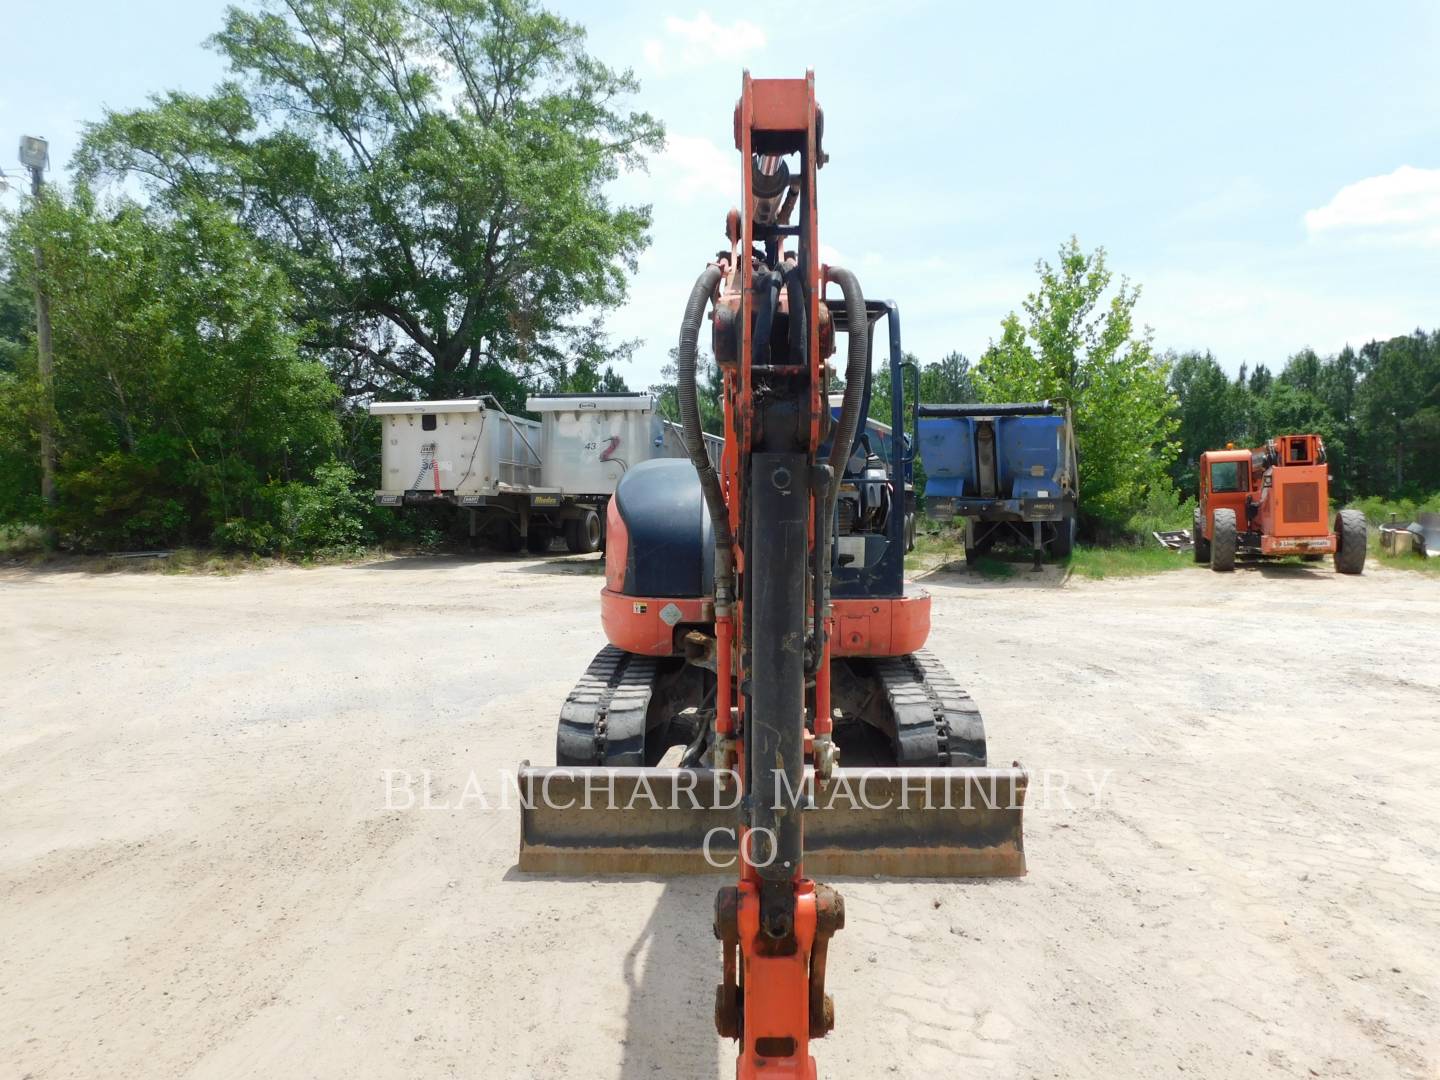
78,0 -> 662,405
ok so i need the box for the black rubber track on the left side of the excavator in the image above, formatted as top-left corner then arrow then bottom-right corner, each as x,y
554,645 -> 657,766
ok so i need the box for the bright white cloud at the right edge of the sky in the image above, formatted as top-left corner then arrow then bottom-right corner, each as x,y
1305,166 -> 1440,248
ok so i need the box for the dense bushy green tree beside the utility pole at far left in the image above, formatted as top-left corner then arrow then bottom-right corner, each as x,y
0,190 -> 338,547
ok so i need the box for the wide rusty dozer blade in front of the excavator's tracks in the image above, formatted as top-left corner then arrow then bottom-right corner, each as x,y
518,765 -> 1027,877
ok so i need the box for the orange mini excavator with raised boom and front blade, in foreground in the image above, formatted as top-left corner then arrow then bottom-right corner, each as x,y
520,72 -> 1025,1080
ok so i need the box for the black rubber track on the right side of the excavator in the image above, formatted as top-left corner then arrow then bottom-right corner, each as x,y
874,649 -> 985,766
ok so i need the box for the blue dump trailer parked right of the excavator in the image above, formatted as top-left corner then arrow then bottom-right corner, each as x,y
916,402 -> 1079,569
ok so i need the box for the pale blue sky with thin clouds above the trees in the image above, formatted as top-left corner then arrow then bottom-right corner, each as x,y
0,0 -> 1440,386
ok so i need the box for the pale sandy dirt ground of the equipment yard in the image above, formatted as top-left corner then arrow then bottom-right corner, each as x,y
0,559 -> 1440,1080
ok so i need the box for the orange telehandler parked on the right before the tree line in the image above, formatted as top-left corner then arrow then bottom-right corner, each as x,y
1194,435 -> 1367,573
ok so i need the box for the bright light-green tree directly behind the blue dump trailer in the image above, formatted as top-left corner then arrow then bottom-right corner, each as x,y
975,236 -> 1178,524
